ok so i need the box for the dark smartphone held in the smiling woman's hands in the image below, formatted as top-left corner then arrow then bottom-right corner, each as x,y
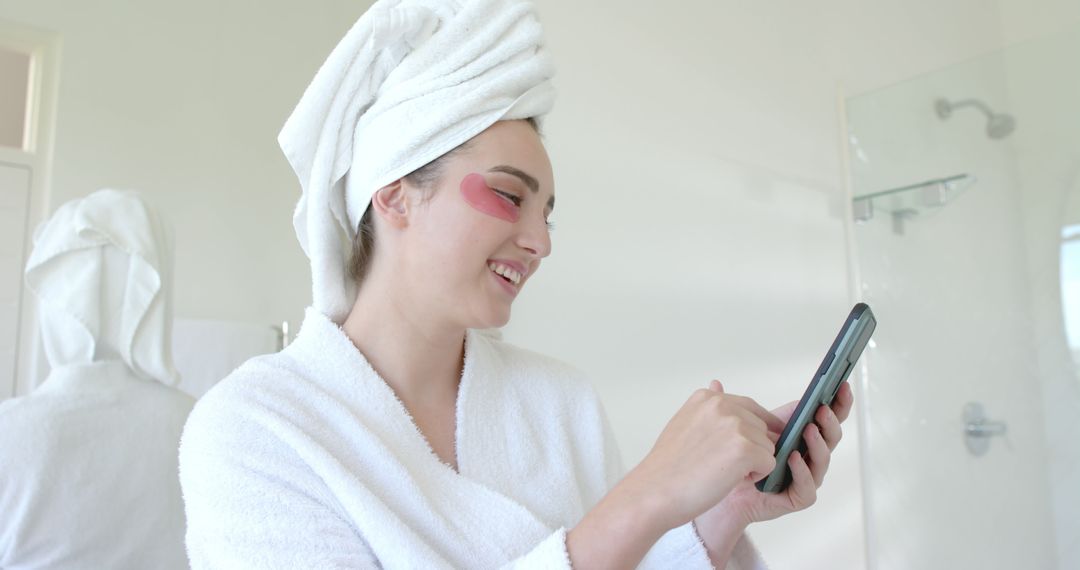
757,303 -> 877,493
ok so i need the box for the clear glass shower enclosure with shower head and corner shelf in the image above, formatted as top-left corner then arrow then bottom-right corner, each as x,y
847,27 -> 1080,570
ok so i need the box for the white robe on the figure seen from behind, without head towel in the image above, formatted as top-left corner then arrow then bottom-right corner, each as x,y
0,361 -> 194,570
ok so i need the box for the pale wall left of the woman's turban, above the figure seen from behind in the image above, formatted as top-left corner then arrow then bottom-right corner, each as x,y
0,0 -> 369,341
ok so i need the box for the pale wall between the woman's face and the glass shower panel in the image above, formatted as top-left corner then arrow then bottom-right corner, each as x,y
508,1 -> 1071,569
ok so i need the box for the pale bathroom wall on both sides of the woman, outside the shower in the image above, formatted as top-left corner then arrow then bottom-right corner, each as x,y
0,0 -> 1075,569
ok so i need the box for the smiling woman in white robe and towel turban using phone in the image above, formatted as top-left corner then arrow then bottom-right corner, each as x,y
180,0 -> 851,568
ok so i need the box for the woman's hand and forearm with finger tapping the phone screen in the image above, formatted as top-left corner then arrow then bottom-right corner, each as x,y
566,389 -> 784,568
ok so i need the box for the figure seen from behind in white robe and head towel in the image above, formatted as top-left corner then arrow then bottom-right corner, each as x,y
0,190 -> 194,570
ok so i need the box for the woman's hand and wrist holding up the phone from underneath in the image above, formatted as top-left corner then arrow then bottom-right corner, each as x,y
694,380 -> 854,552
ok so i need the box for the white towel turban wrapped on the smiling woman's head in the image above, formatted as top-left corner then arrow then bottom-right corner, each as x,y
278,0 -> 554,323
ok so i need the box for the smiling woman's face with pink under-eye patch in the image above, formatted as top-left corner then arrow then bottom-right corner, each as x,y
399,121 -> 555,328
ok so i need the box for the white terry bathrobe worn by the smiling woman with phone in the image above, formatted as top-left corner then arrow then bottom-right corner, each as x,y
180,310 -> 759,570
